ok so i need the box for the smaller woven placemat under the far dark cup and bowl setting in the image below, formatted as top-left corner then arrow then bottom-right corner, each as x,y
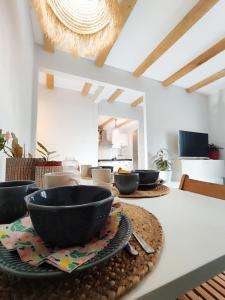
119,185 -> 170,198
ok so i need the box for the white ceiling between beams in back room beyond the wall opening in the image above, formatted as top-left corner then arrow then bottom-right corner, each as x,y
39,70 -> 143,106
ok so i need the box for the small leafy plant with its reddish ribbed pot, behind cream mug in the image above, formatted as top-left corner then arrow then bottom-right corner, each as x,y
35,142 -> 62,187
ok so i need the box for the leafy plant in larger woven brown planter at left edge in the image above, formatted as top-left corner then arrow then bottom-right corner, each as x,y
0,129 -> 39,181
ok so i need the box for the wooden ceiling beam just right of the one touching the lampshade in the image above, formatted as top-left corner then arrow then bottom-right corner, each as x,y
133,0 -> 219,77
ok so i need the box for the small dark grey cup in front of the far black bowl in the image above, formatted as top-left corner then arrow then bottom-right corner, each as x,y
114,173 -> 139,195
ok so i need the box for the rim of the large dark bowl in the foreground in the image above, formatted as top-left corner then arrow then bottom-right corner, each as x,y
24,185 -> 114,211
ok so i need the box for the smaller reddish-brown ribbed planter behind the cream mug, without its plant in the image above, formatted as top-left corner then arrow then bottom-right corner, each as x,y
35,160 -> 63,188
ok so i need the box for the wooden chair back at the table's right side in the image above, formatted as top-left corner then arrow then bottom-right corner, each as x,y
179,175 -> 225,200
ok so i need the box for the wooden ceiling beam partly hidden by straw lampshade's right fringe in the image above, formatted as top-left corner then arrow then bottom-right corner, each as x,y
95,0 -> 137,67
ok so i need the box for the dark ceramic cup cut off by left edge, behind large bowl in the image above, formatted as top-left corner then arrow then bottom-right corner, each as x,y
0,181 -> 35,224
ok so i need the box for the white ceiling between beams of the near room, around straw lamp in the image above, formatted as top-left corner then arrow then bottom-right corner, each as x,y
32,0 -> 225,94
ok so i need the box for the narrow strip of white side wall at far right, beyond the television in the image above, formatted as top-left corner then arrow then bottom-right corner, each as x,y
209,89 -> 225,159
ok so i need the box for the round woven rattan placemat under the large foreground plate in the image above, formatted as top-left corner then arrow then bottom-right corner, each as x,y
0,204 -> 163,300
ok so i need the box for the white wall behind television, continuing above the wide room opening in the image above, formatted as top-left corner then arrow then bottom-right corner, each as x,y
35,46 -> 208,169
